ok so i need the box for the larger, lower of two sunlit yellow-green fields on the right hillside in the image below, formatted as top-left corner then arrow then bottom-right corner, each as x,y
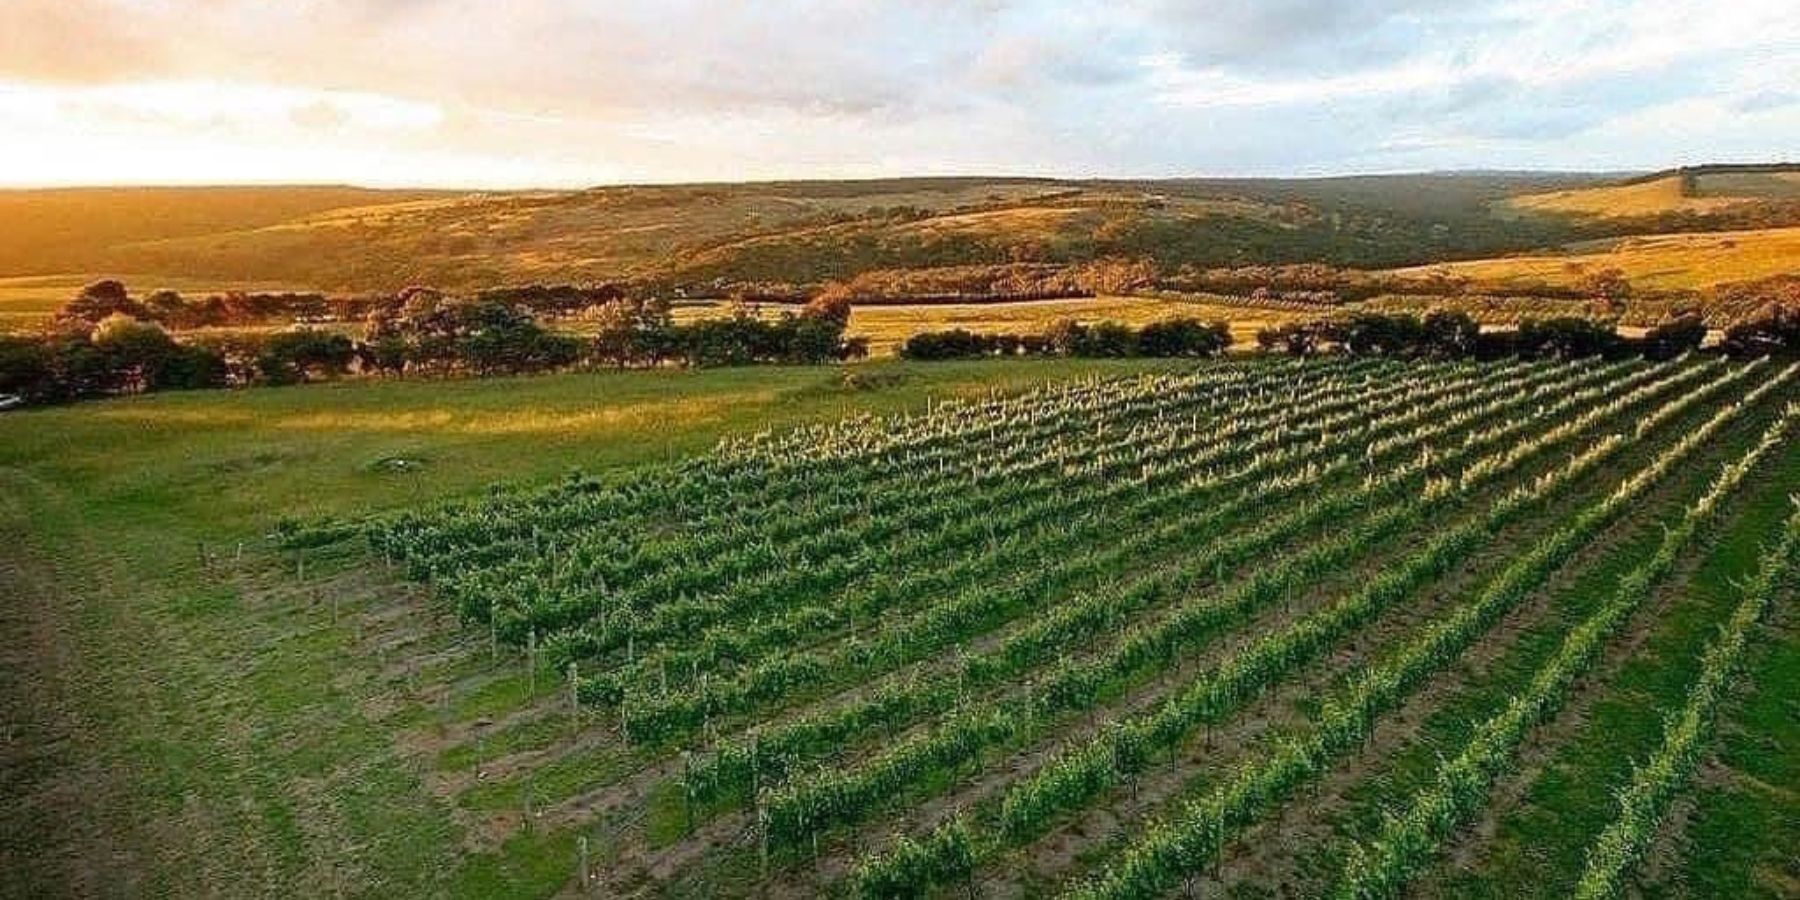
1397,229 -> 1800,290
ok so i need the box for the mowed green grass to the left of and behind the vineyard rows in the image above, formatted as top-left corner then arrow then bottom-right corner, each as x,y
0,360 -> 1209,896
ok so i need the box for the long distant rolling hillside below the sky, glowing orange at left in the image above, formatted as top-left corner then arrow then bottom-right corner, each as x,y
0,173 -> 1600,292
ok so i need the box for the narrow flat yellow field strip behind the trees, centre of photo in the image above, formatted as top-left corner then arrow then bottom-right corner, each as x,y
675,297 -> 1303,356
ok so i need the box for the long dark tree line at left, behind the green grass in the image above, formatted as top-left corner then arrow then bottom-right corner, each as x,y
0,281 -> 868,403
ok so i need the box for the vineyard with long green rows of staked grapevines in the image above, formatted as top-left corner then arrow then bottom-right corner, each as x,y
283,358 -> 1800,898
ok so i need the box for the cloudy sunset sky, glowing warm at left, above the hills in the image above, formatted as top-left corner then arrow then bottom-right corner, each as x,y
0,0 -> 1800,187
